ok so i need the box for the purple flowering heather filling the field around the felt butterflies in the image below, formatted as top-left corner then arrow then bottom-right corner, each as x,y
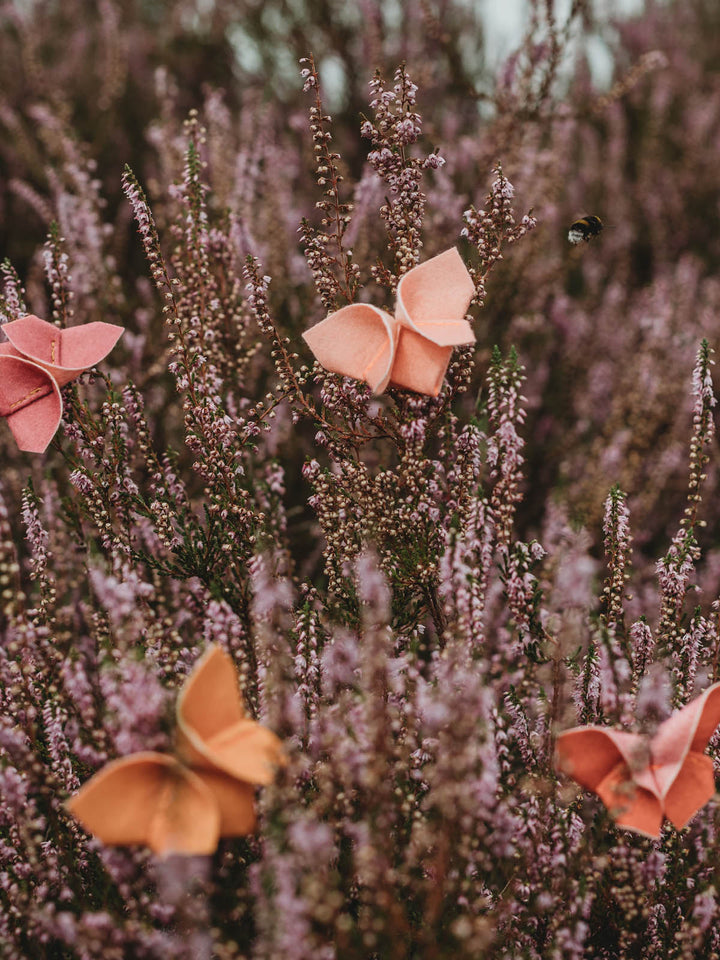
0,0 -> 720,960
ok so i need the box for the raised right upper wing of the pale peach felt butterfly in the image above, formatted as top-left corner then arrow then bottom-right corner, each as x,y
395,247 -> 475,347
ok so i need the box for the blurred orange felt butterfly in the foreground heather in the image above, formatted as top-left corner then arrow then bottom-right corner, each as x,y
67,646 -> 283,855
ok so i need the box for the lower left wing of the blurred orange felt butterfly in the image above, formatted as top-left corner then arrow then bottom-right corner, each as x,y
67,751 -> 220,855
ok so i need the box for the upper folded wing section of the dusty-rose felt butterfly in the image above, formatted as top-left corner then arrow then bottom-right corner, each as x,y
3,314 -> 123,387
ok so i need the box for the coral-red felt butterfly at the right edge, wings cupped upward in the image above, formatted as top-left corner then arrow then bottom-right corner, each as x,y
557,683 -> 720,837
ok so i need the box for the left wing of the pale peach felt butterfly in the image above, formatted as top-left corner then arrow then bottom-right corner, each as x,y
303,303 -> 397,393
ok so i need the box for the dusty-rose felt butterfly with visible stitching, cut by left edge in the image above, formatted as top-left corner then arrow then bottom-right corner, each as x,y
0,315 -> 123,453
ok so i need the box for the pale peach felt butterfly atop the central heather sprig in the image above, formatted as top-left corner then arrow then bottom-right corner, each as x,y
303,247 -> 475,397
